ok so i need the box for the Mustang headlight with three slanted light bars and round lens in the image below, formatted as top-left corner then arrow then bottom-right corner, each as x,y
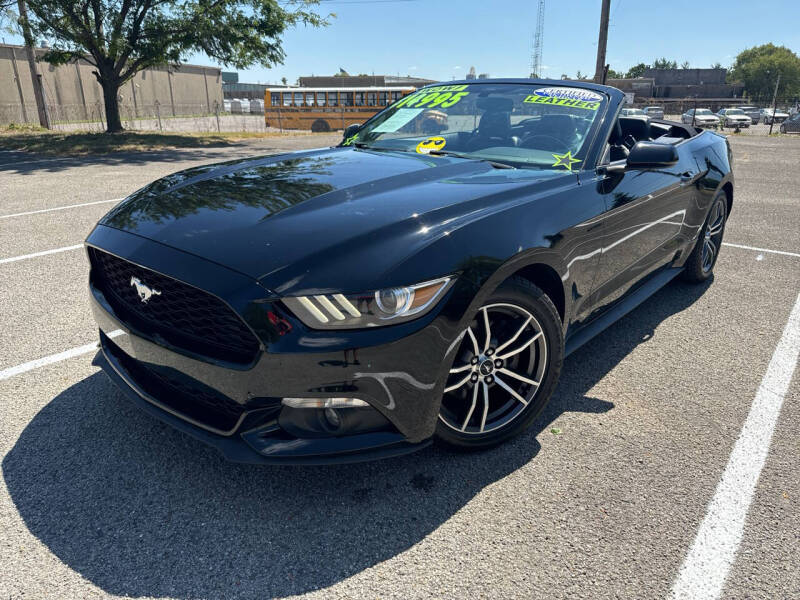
282,277 -> 454,329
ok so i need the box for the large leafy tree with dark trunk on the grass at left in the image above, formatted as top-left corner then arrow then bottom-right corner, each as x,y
15,0 -> 333,133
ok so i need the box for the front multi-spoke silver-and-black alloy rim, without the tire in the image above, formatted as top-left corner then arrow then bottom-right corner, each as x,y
439,303 -> 547,435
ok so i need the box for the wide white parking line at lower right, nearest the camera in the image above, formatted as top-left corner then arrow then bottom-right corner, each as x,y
671,295 -> 800,600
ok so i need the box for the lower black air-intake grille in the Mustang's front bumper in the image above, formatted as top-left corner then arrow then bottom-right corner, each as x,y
100,331 -> 244,433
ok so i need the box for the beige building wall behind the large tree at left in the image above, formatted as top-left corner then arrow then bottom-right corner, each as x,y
0,45 -> 222,124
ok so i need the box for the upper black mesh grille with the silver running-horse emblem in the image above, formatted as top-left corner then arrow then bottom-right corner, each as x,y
89,248 -> 259,364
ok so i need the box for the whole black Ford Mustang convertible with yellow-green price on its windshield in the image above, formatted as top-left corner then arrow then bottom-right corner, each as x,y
86,80 -> 734,463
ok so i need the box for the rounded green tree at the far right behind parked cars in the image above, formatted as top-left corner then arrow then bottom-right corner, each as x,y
731,43 -> 800,101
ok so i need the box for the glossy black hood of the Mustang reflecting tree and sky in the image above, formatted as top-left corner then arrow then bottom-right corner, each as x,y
100,148 -> 577,295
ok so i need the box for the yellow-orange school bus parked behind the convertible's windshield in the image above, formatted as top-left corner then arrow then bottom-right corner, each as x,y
264,87 -> 417,132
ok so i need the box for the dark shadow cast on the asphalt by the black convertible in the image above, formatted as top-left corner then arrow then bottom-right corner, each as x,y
2,284 -> 708,598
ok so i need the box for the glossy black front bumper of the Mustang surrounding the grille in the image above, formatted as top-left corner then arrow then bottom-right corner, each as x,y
87,228 -> 463,464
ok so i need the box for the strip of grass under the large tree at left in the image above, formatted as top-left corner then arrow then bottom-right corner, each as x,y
0,125 -> 322,156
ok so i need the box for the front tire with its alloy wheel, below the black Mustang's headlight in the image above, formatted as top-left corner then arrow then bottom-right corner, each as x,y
435,277 -> 564,450
